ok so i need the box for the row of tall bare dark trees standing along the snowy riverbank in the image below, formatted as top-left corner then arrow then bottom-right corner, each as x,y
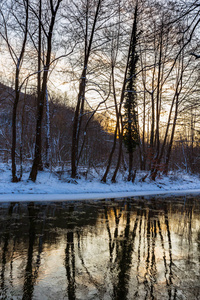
0,0 -> 200,182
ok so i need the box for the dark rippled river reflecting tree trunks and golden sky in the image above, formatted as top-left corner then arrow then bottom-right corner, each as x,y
0,197 -> 200,300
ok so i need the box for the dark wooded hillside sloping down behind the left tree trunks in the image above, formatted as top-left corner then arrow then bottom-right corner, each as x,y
0,83 -> 113,170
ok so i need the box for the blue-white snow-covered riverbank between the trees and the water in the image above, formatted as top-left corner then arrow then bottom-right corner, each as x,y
0,163 -> 200,202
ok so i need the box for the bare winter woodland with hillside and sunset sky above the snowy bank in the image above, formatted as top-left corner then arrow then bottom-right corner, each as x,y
0,0 -> 200,182
